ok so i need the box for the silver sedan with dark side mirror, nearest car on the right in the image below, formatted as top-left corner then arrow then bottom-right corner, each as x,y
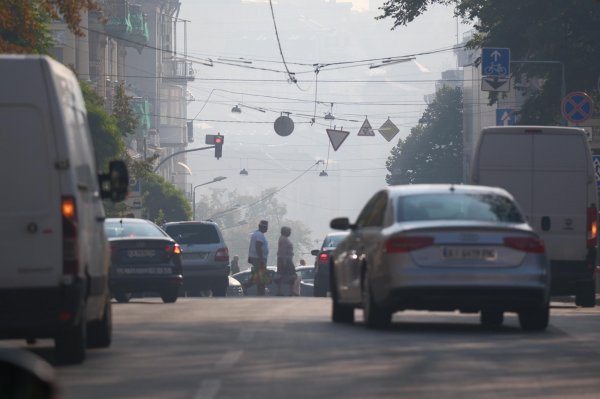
330,184 -> 550,330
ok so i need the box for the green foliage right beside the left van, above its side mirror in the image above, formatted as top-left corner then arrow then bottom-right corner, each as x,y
79,81 -> 125,170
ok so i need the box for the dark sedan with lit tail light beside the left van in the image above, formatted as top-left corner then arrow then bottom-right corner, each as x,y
104,218 -> 183,303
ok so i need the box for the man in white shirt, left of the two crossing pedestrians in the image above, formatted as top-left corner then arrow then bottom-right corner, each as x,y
244,220 -> 271,296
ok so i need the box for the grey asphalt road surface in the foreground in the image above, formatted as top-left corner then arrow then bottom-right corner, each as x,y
3,297 -> 600,399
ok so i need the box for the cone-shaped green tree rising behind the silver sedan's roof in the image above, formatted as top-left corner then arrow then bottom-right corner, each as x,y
386,87 -> 463,184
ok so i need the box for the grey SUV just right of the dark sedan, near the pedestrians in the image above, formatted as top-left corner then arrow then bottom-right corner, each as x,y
163,221 -> 230,296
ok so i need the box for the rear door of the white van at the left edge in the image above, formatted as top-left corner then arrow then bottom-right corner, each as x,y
0,105 -> 62,288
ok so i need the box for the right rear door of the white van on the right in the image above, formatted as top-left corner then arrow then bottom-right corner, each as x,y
530,131 -> 592,260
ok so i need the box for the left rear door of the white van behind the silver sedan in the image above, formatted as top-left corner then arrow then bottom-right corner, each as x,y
473,128 -> 533,220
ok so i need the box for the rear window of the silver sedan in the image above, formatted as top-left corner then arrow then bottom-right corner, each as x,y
397,192 -> 524,223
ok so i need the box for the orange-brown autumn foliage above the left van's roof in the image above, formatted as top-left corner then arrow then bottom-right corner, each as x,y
0,0 -> 100,54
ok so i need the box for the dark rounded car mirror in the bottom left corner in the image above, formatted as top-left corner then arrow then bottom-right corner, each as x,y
0,348 -> 58,399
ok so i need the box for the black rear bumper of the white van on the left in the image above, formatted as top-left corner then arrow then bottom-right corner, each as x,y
0,281 -> 85,339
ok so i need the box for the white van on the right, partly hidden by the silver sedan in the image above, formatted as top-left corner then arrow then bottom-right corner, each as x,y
471,126 -> 598,307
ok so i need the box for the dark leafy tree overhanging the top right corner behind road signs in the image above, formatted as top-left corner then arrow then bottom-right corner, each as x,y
377,0 -> 600,124
